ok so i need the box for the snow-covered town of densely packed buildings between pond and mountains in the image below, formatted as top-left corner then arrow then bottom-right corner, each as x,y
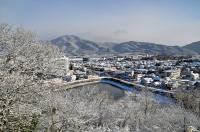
60,55 -> 200,91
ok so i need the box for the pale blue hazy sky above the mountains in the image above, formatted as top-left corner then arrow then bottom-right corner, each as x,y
0,0 -> 200,45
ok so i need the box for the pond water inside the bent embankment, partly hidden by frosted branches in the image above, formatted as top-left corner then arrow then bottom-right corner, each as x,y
73,82 -> 175,105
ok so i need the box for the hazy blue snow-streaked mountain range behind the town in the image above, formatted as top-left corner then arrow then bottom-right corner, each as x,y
51,35 -> 200,55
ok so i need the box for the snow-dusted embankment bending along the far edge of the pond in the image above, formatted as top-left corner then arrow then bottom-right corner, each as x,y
51,77 -> 174,97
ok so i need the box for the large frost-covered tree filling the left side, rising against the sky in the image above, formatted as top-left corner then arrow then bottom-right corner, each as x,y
0,24 -> 62,131
